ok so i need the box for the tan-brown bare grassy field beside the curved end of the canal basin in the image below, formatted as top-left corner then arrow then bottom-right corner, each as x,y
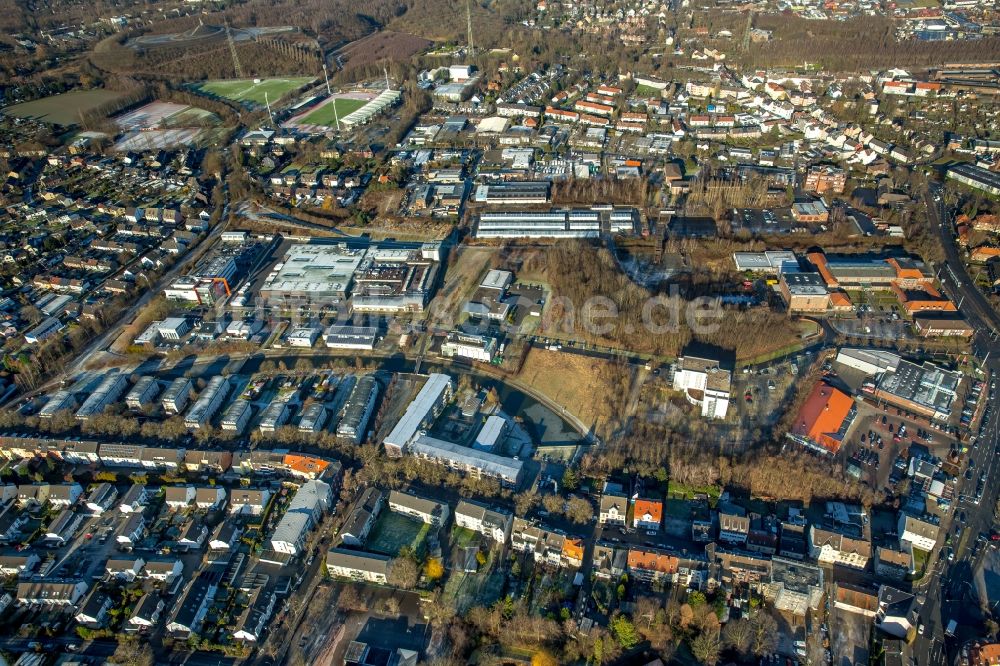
518,349 -> 632,435
